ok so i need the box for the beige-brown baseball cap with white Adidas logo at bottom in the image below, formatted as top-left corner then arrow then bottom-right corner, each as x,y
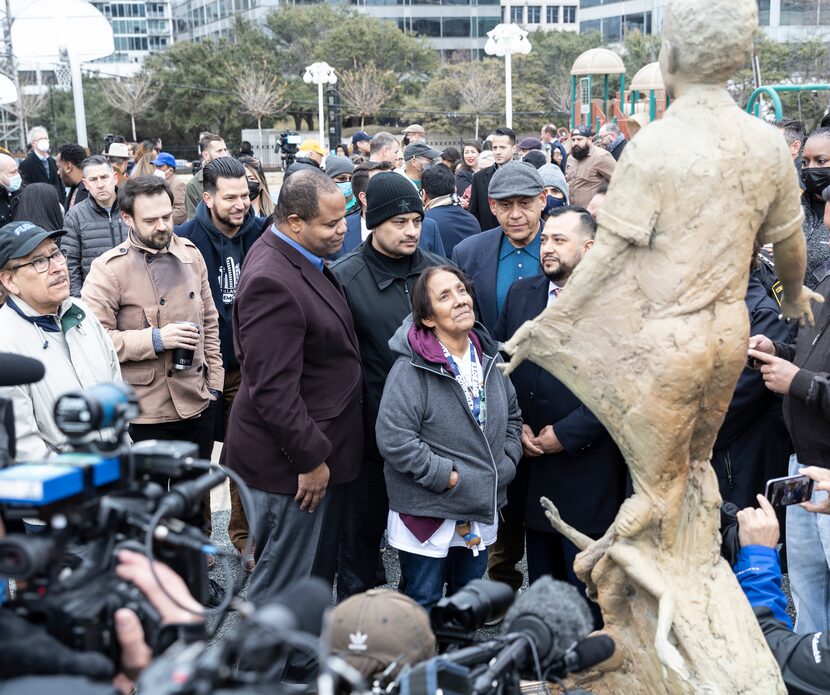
331,589 -> 435,678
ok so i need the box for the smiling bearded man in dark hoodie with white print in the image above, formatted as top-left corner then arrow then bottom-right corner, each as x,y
174,157 -> 265,571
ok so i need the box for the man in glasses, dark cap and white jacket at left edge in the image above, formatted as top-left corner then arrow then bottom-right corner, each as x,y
0,222 -> 121,461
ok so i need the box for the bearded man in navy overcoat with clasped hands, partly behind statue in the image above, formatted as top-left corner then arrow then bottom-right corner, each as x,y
493,207 -> 626,627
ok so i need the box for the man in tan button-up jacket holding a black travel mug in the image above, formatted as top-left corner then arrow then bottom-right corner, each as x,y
82,176 -> 224,459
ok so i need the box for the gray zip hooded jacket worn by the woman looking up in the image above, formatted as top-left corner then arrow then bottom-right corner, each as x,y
375,315 -> 522,523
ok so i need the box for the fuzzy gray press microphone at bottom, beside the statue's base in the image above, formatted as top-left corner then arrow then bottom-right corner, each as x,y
472,576 -> 594,695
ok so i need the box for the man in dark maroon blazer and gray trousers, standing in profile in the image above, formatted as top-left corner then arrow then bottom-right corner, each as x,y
222,169 -> 363,603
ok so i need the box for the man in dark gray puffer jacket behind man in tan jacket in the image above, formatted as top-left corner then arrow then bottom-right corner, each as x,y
61,154 -> 128,297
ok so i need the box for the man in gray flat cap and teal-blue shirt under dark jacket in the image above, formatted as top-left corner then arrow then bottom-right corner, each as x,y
452,162 -> 547,333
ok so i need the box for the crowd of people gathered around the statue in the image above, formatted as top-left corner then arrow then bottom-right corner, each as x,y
0,106 -> 830,692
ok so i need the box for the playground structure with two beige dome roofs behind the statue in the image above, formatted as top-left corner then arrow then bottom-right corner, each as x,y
571,48 -> 669,137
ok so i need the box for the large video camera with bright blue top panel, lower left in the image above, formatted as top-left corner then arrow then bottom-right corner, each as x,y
0,368 -> 233,664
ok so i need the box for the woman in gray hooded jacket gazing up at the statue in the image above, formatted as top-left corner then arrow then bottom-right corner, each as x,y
376,266 -> 522,609
